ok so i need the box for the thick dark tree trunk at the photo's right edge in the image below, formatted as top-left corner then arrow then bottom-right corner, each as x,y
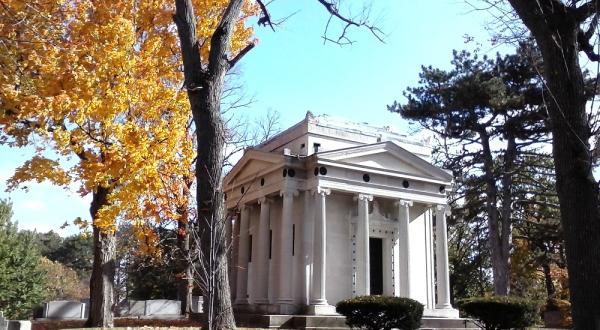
510,0 -> 600,330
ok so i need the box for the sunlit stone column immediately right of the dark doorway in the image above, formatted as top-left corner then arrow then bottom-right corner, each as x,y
396,200 -> 413,298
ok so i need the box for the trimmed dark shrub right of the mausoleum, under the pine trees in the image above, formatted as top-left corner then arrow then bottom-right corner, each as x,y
458,296 -> 538,330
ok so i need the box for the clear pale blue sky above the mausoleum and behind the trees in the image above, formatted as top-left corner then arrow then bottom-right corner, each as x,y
0,0 -> 506,236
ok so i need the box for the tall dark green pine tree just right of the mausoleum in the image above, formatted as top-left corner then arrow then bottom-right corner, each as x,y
389,45 -> 548,295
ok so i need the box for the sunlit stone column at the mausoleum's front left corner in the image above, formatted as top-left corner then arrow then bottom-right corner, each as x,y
309,188 -> 335,314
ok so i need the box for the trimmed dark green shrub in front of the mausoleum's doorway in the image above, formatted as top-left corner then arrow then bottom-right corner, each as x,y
335,296 -> 423,330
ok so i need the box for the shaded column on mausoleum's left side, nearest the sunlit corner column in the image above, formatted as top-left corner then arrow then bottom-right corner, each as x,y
276,190 -> 298,314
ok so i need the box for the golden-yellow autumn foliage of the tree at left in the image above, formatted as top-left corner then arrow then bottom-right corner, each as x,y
0,0 -> 257,240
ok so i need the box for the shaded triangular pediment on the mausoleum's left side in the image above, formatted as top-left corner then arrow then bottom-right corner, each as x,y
225,149 -> 283,185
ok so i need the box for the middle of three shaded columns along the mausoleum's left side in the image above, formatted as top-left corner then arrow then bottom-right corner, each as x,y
254,197 -> 271,305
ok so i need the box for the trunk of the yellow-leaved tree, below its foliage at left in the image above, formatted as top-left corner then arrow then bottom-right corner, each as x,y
86,187 -> 116,328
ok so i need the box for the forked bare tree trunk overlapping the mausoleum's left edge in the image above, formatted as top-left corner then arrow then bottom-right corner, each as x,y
174,0 -> 251,329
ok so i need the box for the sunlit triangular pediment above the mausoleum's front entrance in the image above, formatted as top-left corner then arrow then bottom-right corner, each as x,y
318,141 -> 452,181
